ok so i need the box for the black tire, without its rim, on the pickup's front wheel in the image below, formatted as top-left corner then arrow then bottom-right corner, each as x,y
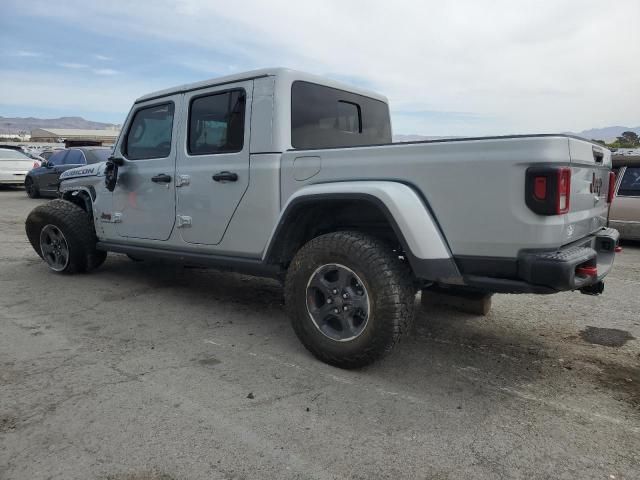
26,199 -> 107,273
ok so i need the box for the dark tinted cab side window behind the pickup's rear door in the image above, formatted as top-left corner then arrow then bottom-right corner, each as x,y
291,81 -> 391,149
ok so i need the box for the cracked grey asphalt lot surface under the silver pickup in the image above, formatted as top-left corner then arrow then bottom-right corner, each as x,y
0,189 -> 640,480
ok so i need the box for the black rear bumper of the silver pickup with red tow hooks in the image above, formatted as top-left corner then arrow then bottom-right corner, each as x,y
463,228 -> 620,293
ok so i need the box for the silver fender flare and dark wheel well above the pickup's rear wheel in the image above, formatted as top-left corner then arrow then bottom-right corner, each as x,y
263,181 -> 461,283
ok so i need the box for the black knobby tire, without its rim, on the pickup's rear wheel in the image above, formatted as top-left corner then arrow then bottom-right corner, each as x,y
284,231 -> 416,369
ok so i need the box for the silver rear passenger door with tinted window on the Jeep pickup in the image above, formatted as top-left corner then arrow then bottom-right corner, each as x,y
176,81 -> 253,245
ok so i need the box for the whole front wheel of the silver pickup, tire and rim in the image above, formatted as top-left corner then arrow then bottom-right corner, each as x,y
26,200 -> 107,273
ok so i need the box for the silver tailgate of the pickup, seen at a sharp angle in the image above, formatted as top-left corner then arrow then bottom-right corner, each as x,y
564,138 -> 611,244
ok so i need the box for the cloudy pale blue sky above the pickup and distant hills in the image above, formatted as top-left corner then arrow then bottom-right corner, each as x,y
0,0 -> 640,136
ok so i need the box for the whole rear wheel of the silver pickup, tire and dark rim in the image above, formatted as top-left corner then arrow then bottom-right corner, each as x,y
285,231 -> 416,368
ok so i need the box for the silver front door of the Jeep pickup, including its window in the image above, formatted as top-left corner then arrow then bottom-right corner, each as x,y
113,95 -> 181,240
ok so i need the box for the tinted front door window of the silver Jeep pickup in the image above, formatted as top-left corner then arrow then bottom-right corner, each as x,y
123,103 -> 175,160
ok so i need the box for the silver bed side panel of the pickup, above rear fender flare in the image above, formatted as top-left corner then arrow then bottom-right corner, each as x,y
281,136 -> 596,257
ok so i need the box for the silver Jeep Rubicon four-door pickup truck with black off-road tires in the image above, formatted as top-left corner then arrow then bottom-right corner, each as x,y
26,69 -> 618,368
